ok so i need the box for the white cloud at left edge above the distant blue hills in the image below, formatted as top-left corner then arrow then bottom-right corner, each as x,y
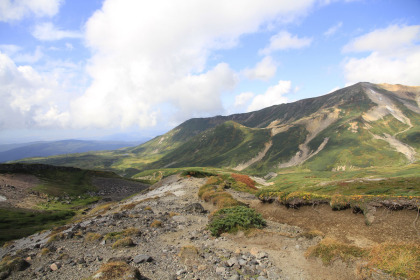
0,52 -> 68,129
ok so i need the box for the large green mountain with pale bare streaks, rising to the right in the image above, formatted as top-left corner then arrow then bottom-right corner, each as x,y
20,83 -> 420,174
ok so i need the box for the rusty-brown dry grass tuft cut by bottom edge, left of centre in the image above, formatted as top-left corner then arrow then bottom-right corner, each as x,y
89,262 -> 141,280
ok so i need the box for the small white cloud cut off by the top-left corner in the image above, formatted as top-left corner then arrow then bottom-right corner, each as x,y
0,0 -> 63,22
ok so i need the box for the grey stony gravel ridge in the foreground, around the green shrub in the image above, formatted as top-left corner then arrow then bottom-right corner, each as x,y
0,175 -> 378,280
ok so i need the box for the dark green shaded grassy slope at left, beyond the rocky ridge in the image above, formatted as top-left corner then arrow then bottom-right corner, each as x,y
0,165 -> 130,244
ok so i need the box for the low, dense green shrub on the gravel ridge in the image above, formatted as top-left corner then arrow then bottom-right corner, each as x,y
208,206 -> 266,236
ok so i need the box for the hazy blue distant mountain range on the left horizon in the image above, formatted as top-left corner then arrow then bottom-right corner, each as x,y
0,140 -> 148,162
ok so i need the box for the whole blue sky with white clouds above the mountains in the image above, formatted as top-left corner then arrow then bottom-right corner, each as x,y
0,0 -> 420,144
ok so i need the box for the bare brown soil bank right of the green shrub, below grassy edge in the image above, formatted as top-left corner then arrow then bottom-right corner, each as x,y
243,197 -> 420,247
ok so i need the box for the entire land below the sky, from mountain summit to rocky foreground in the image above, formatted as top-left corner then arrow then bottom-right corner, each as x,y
0,83 -> 420,280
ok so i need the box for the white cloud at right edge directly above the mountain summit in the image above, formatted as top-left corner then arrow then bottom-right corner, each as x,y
343,25 -> 420,85
